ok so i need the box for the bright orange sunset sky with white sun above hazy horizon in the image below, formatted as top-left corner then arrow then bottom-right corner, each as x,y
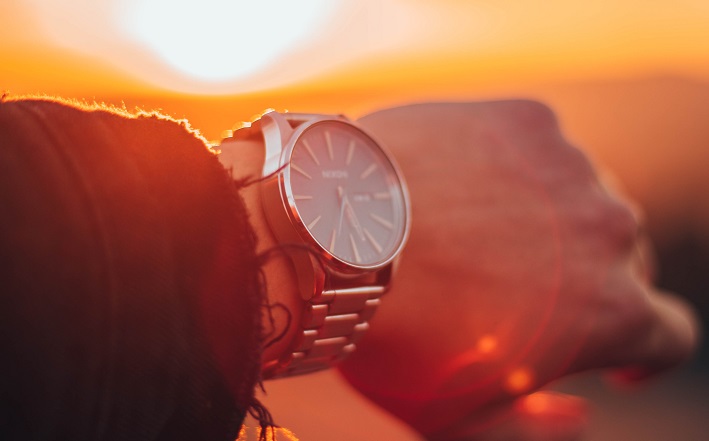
0,0 -> 709,96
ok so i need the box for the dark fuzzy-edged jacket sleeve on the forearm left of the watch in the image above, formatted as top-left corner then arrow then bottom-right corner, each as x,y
0,100 -> 261,441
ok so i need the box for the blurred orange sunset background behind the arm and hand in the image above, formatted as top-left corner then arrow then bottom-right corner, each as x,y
0,0 -> 709,440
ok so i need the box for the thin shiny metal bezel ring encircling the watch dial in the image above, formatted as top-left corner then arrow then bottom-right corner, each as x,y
278,114 -> 411,274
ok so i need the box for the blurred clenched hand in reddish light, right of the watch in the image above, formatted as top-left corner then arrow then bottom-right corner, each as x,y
341,101 -> 697,440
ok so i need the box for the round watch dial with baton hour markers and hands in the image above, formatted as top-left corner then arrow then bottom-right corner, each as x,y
286,121 -> 407,268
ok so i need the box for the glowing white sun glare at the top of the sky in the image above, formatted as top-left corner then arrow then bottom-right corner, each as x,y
119,0 -> 337,81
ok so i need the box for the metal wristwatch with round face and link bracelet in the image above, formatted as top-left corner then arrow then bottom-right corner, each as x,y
218,111 -> 411,378
